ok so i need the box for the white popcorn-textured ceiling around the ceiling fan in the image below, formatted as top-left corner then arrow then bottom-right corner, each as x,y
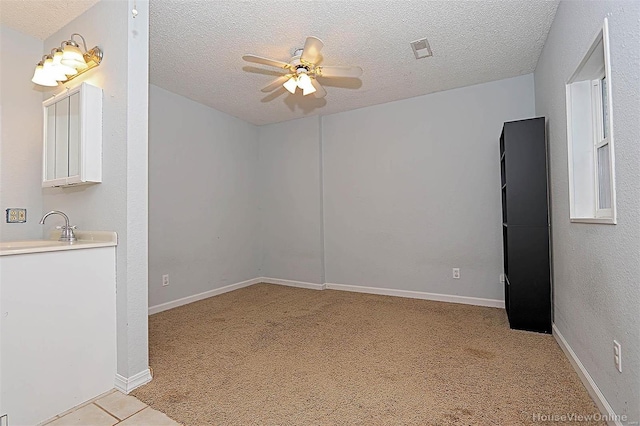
150,0 -> 558,124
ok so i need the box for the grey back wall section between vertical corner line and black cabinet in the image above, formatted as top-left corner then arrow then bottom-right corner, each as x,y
322,74 -> 534,299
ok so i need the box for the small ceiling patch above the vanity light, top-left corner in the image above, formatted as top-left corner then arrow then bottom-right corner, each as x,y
0,0 -> 99,40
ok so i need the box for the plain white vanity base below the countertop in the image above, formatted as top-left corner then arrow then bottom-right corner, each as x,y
0,247 -> 116,426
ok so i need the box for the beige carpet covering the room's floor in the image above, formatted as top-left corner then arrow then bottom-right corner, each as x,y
133,284 -> 604,425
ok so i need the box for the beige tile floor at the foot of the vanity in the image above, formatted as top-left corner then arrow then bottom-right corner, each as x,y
43,389 -> 180,426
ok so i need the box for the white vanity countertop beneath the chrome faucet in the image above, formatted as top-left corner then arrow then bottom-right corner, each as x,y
0,230 -> 118,256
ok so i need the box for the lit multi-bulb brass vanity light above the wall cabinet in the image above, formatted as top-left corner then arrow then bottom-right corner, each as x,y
31,33 -> 102,87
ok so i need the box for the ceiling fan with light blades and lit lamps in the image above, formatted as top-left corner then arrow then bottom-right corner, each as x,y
242,37 -> 362,98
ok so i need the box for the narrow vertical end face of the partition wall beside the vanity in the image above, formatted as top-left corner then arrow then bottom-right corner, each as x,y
122,0 -> 149,377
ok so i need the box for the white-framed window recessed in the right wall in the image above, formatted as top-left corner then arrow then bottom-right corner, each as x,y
566,19 -> 616,224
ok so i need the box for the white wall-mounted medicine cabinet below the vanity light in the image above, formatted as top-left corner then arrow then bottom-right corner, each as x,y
42,83 -> 102,188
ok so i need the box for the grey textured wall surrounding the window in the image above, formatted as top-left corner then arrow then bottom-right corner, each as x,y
535,1 -> 640,421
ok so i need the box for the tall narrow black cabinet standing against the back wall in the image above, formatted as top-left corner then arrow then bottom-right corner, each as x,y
500,117 -> 551,333
